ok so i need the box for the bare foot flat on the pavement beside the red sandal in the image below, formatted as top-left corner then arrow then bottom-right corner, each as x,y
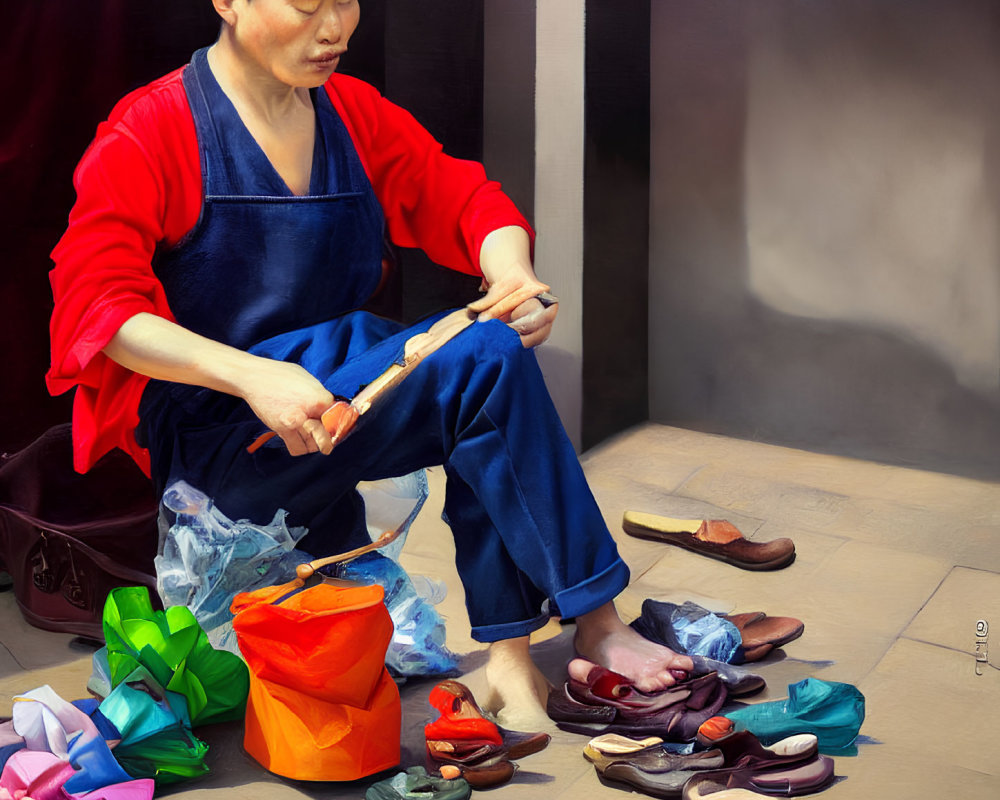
483,636 -> 552,731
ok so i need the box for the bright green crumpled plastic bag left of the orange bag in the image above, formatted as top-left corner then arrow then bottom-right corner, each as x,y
103,586 -> 250,728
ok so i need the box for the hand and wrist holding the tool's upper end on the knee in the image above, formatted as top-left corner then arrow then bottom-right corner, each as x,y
468,227 -> 559,347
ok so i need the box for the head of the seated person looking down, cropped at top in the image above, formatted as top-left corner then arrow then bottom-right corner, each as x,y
212,0 -> 361,87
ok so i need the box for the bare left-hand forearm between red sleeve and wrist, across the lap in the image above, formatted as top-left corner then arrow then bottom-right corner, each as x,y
104,313 -> 261,397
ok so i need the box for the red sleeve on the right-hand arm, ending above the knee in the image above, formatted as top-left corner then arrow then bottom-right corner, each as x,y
326,73 -> 534,275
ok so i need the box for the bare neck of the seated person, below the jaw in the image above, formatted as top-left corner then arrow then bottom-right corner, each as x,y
208,26 -> 312,122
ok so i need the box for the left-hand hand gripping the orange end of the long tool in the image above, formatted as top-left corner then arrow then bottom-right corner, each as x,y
239,358 -> 334,456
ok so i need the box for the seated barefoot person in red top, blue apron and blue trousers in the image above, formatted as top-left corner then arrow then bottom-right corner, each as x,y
47,0 -> 691,726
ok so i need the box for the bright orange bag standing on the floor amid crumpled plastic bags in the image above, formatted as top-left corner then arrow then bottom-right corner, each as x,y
231,583 -> 402,781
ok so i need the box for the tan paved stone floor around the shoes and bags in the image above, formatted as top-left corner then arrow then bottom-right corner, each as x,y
0,424 -> 1000,800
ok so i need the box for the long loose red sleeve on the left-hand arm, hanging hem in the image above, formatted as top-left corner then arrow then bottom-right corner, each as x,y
46,70 -> 201,472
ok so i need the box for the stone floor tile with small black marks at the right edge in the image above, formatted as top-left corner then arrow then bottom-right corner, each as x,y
903,567 -> 1000,667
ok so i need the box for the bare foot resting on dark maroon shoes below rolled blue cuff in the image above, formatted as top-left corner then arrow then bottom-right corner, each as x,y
575,603 -> 694,692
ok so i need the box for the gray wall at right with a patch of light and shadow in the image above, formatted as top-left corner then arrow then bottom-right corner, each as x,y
649,0 -> 1000,478
